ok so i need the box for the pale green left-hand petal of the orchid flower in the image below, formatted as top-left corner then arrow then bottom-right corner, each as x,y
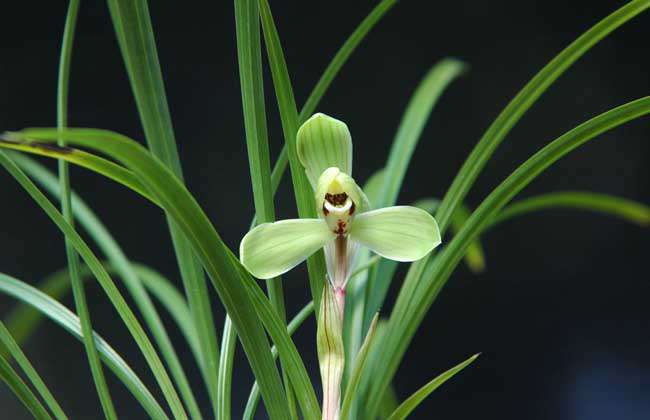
239,219 -> 336,279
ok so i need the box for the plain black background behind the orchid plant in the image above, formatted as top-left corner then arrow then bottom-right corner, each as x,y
0,0 -> 650,419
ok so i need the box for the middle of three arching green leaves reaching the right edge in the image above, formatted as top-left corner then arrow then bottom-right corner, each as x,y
368,97 -> 650,411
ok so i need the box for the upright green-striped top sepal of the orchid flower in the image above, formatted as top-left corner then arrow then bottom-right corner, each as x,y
296,113 -> 352,191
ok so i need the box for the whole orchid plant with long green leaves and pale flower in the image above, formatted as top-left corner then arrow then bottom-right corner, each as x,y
0,0 -> 650,420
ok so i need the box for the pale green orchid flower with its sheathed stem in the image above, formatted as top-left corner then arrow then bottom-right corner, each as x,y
239,114 -> 440,420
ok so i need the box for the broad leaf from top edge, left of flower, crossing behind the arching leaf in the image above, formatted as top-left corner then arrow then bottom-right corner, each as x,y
108,0 -> 219,410
